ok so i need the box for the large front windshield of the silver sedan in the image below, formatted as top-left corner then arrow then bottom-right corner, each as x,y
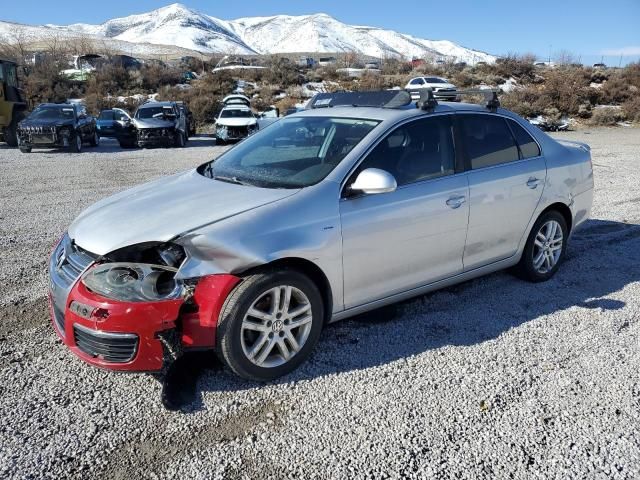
199,117 -> 380,188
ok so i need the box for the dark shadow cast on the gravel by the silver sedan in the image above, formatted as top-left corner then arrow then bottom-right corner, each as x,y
163,220 -> 640,412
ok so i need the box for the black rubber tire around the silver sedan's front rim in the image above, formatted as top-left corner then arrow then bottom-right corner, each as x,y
216,269 -> 325,382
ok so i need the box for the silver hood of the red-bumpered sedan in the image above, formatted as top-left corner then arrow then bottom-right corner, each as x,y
69,169 -> 299,255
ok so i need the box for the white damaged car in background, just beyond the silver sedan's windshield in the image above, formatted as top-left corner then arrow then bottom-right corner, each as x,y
215,95 -> 258,143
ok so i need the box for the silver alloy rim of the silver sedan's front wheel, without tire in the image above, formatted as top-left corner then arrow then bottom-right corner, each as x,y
240,285 -> 313,368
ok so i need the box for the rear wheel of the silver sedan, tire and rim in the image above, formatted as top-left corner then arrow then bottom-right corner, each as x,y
517,210 -> 569,282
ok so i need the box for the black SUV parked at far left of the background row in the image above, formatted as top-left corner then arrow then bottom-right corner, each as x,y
17,103 -> 100,153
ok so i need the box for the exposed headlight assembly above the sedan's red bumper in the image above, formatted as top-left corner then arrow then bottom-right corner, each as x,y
82,263 -> 184,302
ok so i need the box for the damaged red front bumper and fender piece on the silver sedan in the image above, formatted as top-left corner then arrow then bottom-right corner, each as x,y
50,275 -> 240,371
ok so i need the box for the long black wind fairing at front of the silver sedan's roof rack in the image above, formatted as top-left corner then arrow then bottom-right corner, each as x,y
307,90 -> 411,109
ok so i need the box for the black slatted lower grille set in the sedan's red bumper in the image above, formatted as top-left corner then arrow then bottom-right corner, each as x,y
73,324 -> 138,363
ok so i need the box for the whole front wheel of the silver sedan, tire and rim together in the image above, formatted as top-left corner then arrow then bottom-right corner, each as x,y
216,270 -> 324,381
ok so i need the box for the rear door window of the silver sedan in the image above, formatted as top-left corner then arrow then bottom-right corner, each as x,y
460,114 -> 520,170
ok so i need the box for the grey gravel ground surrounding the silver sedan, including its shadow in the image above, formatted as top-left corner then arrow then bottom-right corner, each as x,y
0,129 -> 640,479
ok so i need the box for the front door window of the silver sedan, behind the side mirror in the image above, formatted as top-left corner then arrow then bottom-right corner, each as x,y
354,115 -> 455,187
